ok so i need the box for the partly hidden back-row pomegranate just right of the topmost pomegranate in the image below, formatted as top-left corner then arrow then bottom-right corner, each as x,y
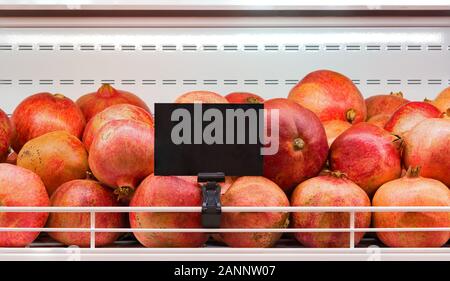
366,92 -> 409,119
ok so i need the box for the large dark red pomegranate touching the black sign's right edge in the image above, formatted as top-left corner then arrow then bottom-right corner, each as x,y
264,98 -> 328,193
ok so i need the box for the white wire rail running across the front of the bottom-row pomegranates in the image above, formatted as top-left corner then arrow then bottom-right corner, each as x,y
0,206 -> 450,249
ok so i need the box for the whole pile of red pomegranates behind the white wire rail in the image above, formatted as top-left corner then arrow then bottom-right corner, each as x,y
0,70 -> 450,248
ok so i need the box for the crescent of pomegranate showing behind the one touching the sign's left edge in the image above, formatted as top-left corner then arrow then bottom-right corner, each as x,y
83,104 -> 153,151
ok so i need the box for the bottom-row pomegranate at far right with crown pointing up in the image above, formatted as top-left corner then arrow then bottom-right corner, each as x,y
372,168 -> 450,248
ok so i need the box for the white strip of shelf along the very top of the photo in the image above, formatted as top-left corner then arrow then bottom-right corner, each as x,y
0,0 -> 449,11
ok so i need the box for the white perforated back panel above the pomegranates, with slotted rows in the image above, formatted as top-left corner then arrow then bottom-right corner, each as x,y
0,27 -> 450,113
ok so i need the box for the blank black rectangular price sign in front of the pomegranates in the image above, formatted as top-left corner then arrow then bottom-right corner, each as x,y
155,103 -> 264,176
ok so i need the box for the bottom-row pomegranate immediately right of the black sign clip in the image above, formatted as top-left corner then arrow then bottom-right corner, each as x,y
220,177 -> 289,248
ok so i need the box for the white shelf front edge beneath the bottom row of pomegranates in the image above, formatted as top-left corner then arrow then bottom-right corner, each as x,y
0,239 -> 450,261
